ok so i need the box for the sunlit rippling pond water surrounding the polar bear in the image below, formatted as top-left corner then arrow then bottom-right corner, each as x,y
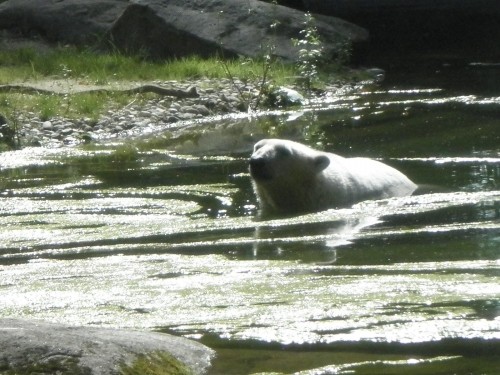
0,64 -> 500,374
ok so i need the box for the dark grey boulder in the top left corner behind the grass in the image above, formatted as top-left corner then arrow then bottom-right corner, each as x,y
0,0 -> 128,45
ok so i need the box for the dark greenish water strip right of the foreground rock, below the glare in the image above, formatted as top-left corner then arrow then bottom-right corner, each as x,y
200,337 -> 498,375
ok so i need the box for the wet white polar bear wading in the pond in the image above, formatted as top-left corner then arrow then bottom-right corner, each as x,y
249,139 -> 417,216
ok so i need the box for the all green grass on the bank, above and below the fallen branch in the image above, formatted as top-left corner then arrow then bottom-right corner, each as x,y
0,47 -> 296,125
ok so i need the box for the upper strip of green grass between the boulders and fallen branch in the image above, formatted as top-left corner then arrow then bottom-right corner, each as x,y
0,48 -> 296,84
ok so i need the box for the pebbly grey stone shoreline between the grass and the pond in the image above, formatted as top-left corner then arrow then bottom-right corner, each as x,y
7,79 -> 352,148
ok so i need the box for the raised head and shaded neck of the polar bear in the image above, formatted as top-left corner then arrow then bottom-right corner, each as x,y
250,139 -> 330,213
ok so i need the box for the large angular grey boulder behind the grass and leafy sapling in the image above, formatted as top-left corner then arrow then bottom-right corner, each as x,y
110,0 -> 368,60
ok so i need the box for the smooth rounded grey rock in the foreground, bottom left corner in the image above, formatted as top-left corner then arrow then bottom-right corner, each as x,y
0,319 -> 214,375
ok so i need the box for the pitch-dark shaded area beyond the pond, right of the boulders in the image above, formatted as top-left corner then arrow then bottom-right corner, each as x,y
324,0 -> 500,71
